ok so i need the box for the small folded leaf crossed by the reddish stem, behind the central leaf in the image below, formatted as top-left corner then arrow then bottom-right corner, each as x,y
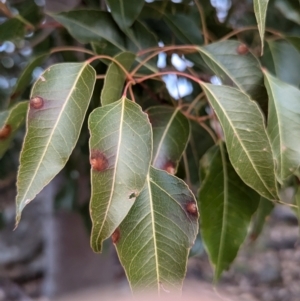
101,52 -> 135,106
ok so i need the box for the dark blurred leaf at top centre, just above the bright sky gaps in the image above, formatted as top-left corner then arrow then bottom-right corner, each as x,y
163,13 -> 203,45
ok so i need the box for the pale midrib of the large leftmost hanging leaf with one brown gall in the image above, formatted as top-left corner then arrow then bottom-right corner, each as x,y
20,63 -> 88,203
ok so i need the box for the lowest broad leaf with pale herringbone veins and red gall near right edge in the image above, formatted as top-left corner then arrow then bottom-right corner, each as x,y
112,168 -> 198,295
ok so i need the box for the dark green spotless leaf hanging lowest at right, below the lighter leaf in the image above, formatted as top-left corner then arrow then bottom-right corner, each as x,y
199,144 -> 259,281
